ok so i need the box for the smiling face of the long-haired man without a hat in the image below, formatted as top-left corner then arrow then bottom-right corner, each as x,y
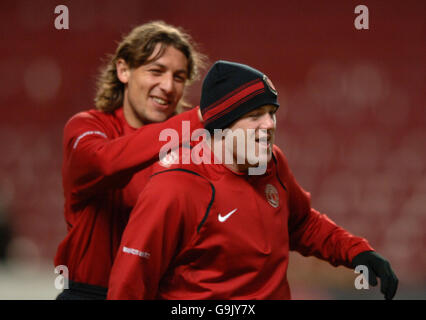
117,44 -> 188,128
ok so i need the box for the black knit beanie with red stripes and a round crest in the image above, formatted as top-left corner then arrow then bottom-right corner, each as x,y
200,60 -> 280,132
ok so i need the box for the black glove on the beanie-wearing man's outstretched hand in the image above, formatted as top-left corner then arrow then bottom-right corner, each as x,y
352,251 -> 398,300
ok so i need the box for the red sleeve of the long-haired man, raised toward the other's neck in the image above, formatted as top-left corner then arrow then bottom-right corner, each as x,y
63,108 -> 202,201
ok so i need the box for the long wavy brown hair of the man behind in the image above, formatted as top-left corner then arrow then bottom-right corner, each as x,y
95,21 -> 206,112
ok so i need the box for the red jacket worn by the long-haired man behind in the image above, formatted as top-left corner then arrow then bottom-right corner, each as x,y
54,108 -> 202,287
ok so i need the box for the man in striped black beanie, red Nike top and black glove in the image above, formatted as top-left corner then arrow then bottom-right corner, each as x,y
108,61 -> 398,300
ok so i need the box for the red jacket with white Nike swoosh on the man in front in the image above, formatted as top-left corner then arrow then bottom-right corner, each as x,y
108,146 -> 372,300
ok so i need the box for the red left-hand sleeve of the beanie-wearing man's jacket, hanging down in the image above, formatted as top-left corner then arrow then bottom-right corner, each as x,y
108,168 -> 209,300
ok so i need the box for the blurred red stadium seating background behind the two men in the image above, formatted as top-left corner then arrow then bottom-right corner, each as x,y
0,0 -> 426,299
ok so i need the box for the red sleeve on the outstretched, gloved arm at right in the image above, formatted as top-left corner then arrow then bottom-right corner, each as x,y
272,148 -> 373,267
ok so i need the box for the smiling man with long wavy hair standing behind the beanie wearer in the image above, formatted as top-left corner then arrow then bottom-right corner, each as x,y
54,21 -> 203,299
